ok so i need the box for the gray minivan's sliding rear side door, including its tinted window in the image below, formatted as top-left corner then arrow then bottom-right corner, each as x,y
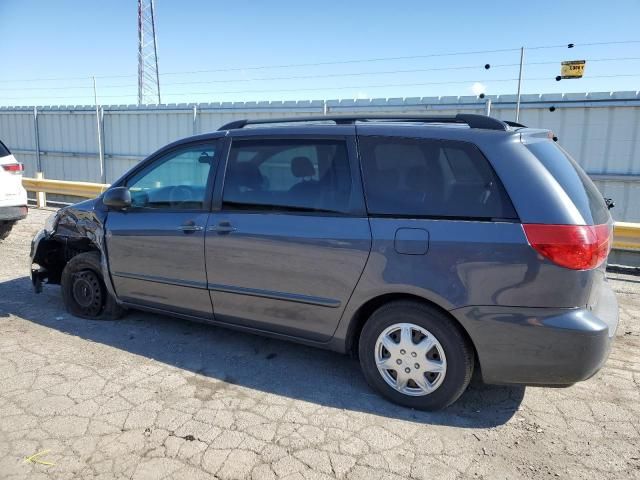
205,138 -> 371,342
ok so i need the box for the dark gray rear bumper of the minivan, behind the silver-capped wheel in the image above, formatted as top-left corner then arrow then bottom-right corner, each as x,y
451,283 -> 618,385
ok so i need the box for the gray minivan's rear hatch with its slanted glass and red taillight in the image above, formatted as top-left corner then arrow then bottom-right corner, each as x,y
522,132 -> 613,307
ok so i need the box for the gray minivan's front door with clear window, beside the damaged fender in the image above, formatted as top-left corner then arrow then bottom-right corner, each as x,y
106,141 -> 219,318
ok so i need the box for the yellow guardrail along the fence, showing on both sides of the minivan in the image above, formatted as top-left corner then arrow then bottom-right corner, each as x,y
22,173 -> 640,252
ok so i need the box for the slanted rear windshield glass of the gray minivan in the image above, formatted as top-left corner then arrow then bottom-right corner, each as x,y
525,140 -> 609,225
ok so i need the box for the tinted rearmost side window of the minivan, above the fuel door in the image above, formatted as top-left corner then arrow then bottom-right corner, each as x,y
359,137 -> 517,220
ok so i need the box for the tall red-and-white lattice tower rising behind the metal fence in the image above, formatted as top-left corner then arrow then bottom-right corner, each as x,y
138,0 -> 162,105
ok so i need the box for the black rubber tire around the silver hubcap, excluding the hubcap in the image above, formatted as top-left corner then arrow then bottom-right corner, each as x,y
358,300 -> 474,410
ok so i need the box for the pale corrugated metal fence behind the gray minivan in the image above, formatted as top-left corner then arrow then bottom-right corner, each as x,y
0,92 -> 640,222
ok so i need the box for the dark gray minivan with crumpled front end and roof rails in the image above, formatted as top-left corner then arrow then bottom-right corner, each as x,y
31,114 -> 618,409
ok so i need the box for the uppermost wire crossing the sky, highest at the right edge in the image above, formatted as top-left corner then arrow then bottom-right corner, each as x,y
0,40 -> 640,83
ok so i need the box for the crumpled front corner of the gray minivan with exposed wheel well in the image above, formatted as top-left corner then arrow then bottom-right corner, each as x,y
31,200 -> 113,293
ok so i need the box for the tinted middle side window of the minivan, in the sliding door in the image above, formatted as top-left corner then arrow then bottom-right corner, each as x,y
223,139 -> 351,213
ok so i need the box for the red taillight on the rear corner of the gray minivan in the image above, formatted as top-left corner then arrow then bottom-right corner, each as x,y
522,224 -> 613,270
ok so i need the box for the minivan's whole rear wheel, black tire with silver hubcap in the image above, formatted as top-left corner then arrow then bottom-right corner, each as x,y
359,301 -> 474,410
